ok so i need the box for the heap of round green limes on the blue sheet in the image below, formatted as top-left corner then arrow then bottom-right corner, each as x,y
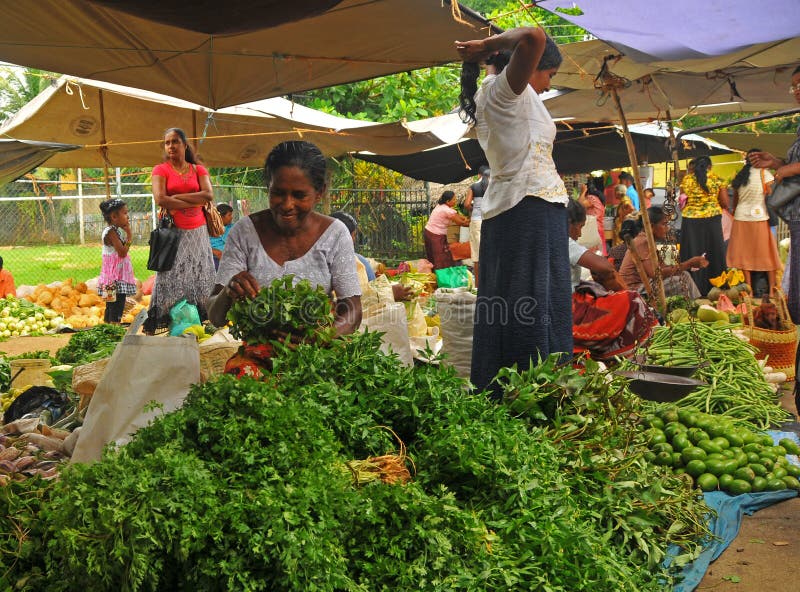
645,405 -> 800,495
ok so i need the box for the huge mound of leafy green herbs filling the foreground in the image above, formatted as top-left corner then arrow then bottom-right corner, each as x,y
0,333 -> 707,592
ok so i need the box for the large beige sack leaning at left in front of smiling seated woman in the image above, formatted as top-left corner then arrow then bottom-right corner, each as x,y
72,335 -> 200,462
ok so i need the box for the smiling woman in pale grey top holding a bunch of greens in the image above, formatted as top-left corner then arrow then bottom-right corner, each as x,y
208,141 -> 361,370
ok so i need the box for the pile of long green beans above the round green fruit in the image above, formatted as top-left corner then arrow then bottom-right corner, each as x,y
647,323 -> 791,429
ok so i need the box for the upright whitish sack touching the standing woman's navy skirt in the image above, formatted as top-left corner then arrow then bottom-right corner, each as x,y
434,289 -> 477,378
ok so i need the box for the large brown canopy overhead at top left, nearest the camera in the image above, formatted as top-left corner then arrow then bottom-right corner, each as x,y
0,0 -> 489,109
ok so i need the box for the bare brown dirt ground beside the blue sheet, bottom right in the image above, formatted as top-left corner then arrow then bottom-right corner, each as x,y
697,389 -> 800,592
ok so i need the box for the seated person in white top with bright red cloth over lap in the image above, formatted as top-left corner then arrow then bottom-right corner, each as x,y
567,200 -> 658,360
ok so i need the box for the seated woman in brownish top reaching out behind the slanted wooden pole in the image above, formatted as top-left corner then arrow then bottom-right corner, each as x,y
619,207 -> 708,299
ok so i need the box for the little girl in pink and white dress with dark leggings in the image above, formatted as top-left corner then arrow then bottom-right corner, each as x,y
97,198 -> 136,323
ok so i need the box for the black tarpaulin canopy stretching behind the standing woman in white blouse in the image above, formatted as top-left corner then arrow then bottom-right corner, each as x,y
354,123 -> 731,184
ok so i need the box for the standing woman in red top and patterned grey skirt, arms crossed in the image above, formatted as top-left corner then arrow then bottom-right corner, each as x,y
144,127 -> 214,335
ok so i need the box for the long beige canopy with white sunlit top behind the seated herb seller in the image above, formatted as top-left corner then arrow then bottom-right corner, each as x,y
0,77 -> 466,168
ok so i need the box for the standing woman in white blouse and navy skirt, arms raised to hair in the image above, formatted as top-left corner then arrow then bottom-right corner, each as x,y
456,27 -> 572,398
